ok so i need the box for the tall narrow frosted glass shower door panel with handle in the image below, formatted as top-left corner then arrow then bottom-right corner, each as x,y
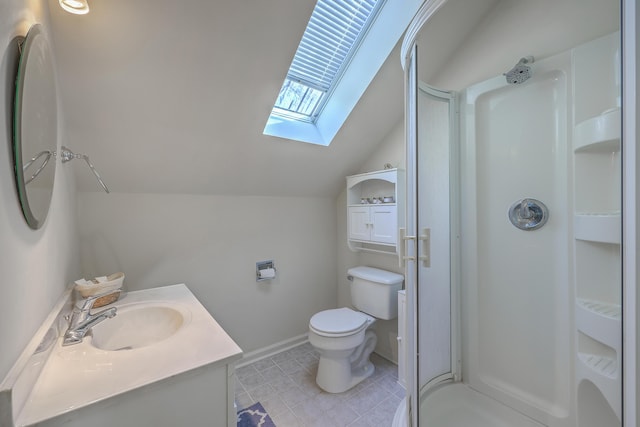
416,83 -> 457,393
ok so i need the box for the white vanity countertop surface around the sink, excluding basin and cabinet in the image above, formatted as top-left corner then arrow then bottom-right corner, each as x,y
16,284 -> 242,426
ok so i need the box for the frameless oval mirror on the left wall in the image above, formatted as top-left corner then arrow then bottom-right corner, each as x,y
13,24 -> 58,230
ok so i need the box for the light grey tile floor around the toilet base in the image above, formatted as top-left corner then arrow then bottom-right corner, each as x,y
236,343 -> 405,427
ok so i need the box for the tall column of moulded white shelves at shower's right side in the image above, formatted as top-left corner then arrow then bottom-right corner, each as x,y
571,30 -> 622,427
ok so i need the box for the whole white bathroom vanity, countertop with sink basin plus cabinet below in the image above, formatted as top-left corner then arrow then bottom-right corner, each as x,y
0,284 -> 242,427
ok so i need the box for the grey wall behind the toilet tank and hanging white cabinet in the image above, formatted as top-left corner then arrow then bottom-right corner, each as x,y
336,121 -> 406,362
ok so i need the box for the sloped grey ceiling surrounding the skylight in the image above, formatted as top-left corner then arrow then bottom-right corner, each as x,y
49,0 -> 404,197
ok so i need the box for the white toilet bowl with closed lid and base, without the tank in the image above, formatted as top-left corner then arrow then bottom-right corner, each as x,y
309,307 -> 378,393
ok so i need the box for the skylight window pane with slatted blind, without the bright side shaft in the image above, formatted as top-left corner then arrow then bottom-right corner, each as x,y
272,0 -> 384,122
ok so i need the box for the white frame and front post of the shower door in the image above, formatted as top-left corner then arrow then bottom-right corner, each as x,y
401,44 -> 461,426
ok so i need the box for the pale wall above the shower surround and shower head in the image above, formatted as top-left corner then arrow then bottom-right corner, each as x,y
428,0 -> 620,90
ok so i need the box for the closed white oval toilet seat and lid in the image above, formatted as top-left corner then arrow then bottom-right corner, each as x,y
309,307 -> 371,337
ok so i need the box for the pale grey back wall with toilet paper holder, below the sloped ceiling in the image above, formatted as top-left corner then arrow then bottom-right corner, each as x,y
78,192 -> 337,352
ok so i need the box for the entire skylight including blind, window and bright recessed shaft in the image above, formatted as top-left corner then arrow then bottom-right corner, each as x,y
263,0 -> 424,146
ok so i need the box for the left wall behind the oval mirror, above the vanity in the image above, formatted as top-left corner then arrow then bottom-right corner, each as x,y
0,0 -> 79,380
